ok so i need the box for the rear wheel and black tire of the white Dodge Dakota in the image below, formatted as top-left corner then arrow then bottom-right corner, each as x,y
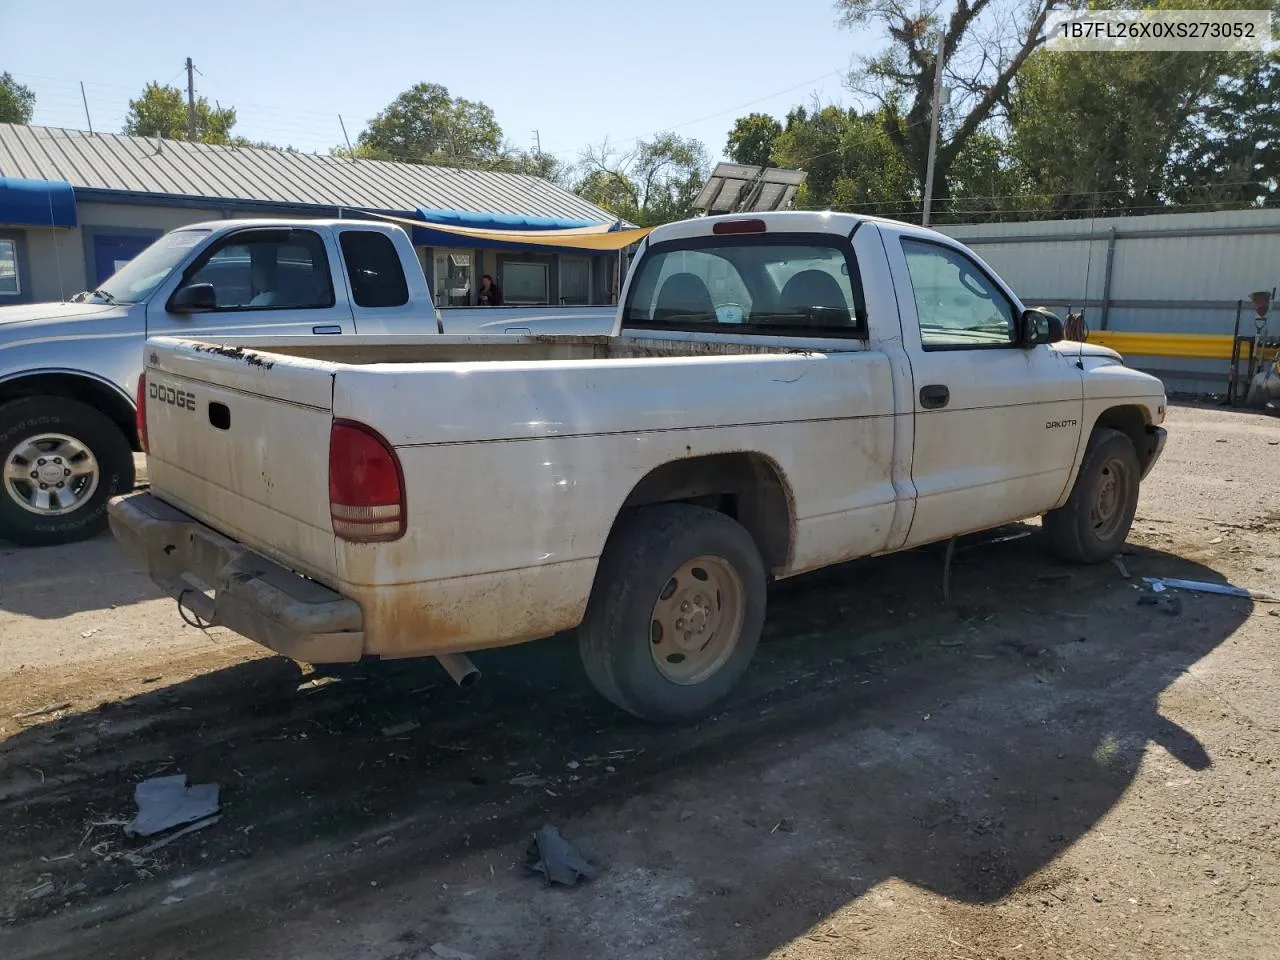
579,503 -> 765,723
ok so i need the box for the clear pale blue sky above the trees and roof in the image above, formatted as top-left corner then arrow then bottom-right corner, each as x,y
0,0 -> 879,163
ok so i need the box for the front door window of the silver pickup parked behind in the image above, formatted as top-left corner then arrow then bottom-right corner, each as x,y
187,230 -> 334,310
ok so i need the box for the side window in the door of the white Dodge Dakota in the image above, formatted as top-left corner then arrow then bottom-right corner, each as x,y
902,238 -> 1016,349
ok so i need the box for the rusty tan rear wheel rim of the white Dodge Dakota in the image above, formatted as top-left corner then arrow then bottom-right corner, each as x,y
649,557 -> 746,686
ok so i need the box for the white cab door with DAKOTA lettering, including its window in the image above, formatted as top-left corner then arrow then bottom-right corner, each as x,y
886,236 -> 1084,547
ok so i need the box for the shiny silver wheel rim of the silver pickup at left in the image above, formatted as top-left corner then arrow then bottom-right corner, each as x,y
4,434 -> 101,517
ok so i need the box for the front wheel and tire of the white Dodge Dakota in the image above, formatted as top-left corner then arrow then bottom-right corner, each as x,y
1044,428 -> 1142,563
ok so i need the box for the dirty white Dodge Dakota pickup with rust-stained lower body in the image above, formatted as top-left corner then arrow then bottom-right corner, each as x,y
110,212 -> 1165,721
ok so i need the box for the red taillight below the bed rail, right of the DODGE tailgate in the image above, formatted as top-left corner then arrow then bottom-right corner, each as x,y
329,420 -> 406,543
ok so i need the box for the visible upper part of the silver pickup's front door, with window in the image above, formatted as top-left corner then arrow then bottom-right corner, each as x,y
147,228 -> 353,337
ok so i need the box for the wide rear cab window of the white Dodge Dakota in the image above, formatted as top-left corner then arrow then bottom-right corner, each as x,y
623,233 -> 867,338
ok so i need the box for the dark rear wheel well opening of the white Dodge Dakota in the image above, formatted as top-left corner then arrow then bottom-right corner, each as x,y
622,453 -> 792,570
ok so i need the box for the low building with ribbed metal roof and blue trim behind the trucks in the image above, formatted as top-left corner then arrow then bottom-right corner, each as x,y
0,124 -> 622,306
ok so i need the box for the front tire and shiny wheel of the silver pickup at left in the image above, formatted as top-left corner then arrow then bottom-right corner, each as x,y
0,397 -> 133,547
